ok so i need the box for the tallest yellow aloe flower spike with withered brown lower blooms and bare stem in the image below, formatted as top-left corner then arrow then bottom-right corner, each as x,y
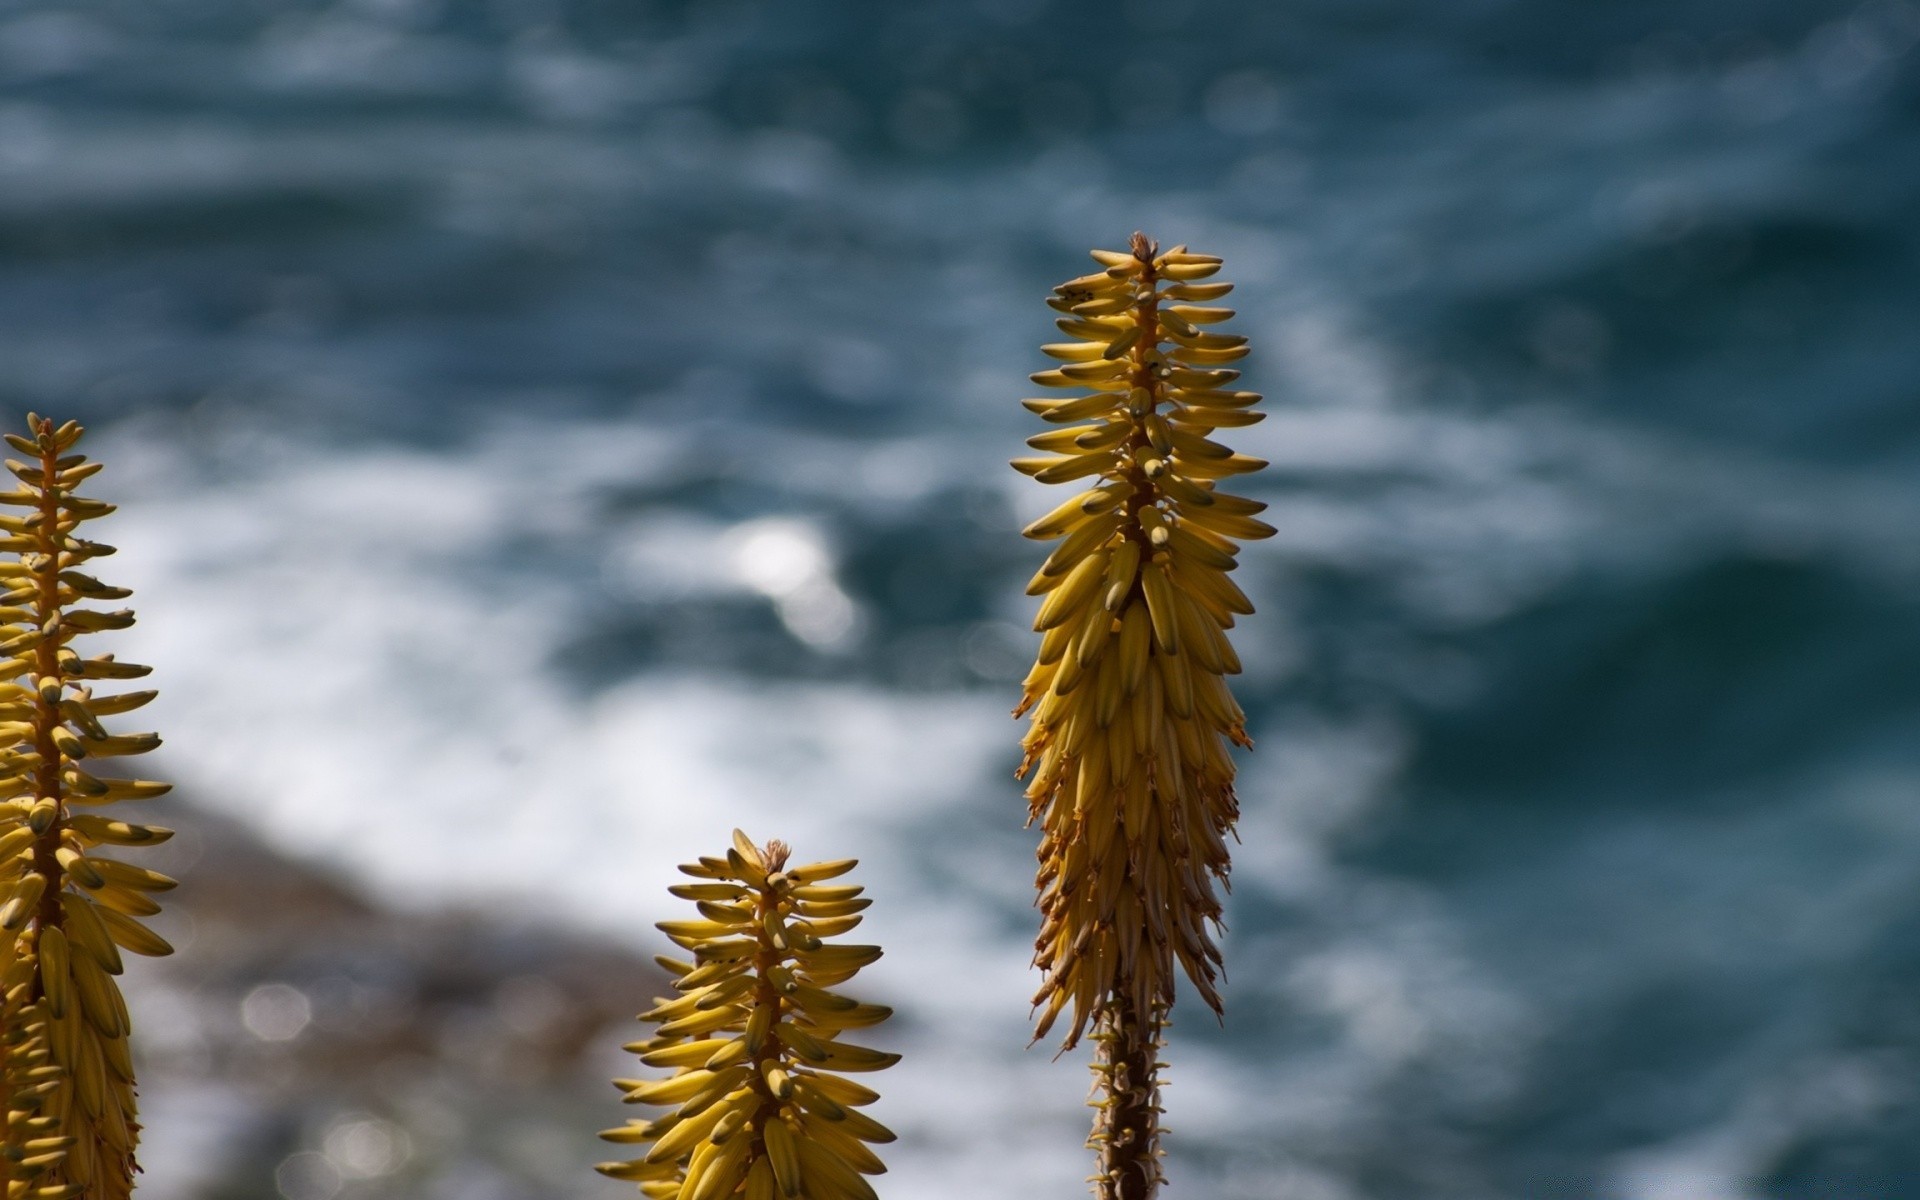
1014,234 -> 1273,1200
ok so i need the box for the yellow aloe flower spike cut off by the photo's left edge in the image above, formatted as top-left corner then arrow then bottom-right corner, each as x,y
0,415 -> 173,1200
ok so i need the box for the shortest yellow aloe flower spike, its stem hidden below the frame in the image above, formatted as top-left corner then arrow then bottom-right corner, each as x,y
599,829 -> 900,1200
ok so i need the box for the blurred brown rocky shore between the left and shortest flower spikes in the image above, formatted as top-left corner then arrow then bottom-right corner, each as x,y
123,799 -> 662,1200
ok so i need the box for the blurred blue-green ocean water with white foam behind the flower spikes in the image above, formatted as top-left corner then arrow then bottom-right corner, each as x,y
0,0 -> 1920,1200
